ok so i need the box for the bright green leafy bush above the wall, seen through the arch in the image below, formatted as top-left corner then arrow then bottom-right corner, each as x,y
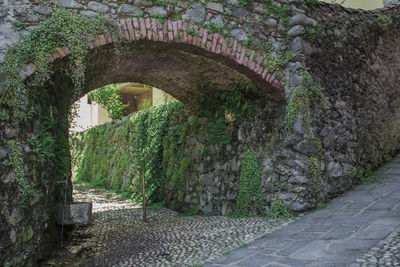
89,84 -> 128,119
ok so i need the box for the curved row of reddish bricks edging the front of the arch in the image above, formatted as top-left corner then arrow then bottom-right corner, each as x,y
20,18 -> 283,89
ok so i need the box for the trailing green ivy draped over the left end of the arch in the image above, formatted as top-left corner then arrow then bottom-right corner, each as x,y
0,8 -> 118,118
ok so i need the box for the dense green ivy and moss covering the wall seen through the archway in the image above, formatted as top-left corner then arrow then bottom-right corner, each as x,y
71,102 -> 191,205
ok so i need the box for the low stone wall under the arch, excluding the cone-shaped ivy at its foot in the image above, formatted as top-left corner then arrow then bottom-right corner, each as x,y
71,101 -> 285,215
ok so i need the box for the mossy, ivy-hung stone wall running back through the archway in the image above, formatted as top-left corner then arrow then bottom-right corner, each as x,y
70,85 -> 284,216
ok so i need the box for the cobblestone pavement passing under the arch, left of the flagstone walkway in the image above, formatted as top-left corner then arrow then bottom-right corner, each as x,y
46,185 -> 289,267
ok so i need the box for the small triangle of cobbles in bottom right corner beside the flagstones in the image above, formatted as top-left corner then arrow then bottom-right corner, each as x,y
351,227 -> 400,267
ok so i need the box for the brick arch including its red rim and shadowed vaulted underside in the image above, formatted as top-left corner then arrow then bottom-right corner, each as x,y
21,18 -> 285,103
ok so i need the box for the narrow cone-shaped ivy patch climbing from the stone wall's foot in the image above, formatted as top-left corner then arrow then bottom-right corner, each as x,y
235,150 -> 264,217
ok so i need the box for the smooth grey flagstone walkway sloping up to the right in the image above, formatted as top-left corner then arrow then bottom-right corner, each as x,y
204,157 -> 400,267
